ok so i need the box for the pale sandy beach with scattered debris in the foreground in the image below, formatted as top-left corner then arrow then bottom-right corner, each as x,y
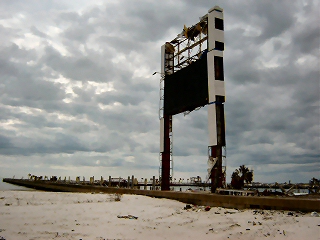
0,191 -> 320,240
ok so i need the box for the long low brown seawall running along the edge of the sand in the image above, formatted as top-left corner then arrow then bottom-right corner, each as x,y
3,178 -> 320,212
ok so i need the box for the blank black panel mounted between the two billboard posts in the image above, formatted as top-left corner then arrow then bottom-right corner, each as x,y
164,57 -> 209,115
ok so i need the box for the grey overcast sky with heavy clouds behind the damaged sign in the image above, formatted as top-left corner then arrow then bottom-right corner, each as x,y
0,0 -> 320,182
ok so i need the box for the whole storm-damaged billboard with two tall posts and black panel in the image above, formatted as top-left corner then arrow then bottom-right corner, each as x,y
159,6 -> 226,192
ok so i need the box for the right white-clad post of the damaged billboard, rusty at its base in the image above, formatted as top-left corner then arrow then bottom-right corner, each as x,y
207,6 -> 226,193
